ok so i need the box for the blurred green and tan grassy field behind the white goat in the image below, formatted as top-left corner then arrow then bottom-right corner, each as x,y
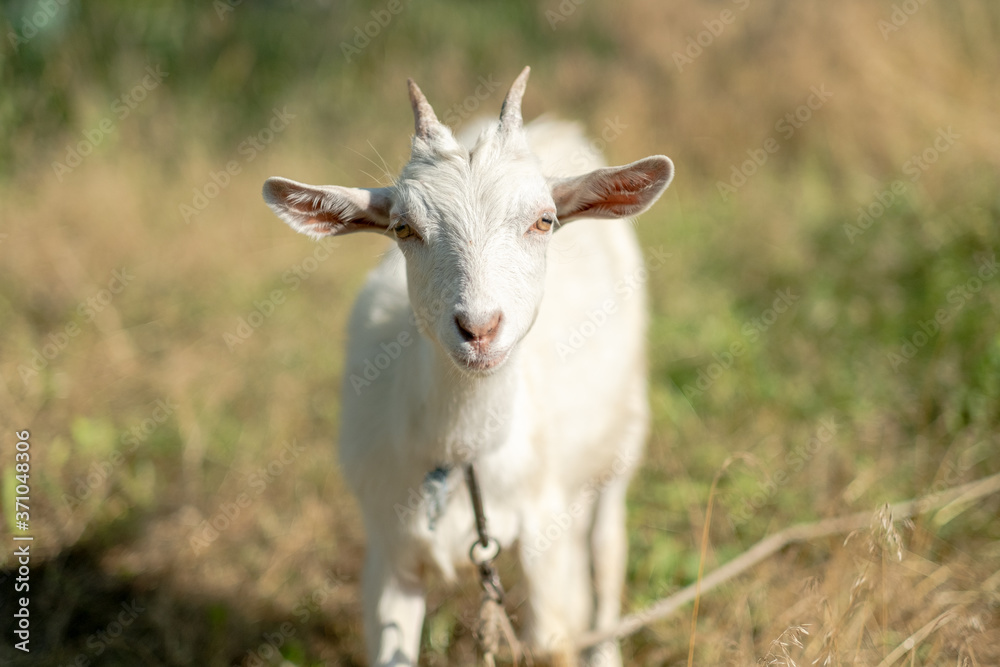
0,0 -> 1000,666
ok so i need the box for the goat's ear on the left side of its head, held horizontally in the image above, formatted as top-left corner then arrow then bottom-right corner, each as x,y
264,178 -> 392,239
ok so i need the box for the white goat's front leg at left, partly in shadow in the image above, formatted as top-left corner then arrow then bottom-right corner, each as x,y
362,546 -> 426,667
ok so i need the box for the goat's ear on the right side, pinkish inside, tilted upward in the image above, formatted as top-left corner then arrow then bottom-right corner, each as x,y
551,155 -> 674,222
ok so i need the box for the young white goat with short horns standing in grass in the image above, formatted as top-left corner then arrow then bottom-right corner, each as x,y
264,67 -> 673,665
